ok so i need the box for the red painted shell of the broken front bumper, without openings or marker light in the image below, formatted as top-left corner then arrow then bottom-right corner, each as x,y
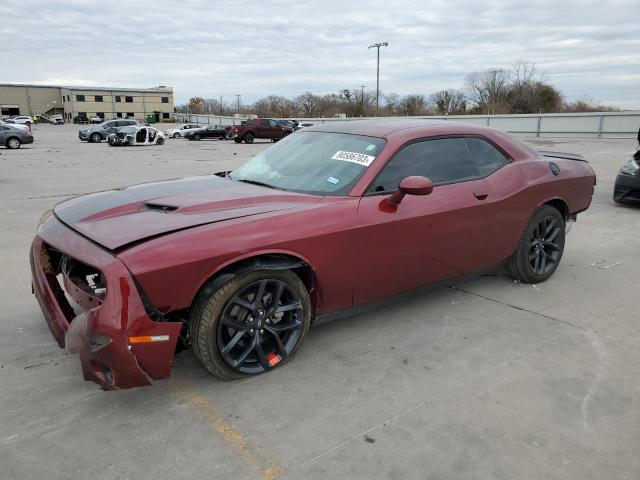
30,216 -> 182,389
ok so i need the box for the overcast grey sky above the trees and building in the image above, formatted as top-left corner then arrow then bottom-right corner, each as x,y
0,0 -> 640,109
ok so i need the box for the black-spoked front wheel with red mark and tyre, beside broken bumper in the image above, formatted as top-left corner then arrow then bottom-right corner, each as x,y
189,270 -> 311,380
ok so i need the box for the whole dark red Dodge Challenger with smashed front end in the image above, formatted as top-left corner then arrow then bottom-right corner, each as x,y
31,120 -> 595,389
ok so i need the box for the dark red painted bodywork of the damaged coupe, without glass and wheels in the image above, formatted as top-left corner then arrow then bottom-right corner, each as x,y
32,121 -> 595,388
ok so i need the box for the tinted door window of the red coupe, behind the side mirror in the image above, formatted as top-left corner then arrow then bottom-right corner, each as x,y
369,138 -> 478,192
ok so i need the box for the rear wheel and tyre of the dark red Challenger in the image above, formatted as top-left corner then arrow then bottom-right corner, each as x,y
507,205 -> 565,283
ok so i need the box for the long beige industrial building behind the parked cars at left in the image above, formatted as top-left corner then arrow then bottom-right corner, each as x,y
0,83 -> 174,122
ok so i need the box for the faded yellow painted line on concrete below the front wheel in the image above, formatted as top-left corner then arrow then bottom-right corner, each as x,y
179,382 -> 285,480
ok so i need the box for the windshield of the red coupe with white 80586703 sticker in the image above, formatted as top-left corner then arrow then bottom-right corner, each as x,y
229,132 -> 386,195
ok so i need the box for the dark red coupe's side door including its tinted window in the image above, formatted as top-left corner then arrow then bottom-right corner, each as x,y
354,138 -> 489,304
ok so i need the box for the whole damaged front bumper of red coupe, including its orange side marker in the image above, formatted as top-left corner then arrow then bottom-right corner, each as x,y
30,215 -> 182,390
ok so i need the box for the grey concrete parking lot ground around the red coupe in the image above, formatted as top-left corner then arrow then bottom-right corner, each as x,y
0,125 -> 640,480
